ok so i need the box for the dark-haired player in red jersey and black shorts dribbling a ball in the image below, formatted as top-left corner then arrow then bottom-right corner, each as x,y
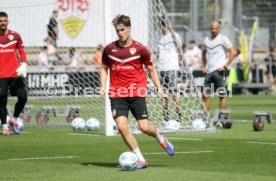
99,15 -> 174,169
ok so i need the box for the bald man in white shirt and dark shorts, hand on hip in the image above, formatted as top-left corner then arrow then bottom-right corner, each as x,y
202,21 -> 236,110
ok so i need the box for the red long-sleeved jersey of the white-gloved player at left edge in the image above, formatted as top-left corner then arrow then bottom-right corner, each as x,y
0,30 -> 26,78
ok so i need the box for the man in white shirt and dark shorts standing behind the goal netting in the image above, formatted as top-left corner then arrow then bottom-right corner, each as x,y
157,21 -> 182,121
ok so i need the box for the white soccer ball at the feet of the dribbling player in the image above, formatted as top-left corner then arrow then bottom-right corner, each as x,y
119,151 -> 138,170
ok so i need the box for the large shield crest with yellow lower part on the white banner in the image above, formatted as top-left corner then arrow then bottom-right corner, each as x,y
58,0 -> 90,38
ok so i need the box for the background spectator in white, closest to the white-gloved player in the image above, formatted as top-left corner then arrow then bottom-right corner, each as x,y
38,46 -> 53,72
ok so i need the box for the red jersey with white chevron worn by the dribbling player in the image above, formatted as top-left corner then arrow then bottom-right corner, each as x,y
102,40 -> 152,98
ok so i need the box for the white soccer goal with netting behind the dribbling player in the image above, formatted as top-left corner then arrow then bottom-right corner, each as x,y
1,0 -> 212,132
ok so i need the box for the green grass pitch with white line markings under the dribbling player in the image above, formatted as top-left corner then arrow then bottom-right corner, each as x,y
0,96 -> 276,181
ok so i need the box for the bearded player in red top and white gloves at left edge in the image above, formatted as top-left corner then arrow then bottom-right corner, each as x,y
0,12 -> 27,136
